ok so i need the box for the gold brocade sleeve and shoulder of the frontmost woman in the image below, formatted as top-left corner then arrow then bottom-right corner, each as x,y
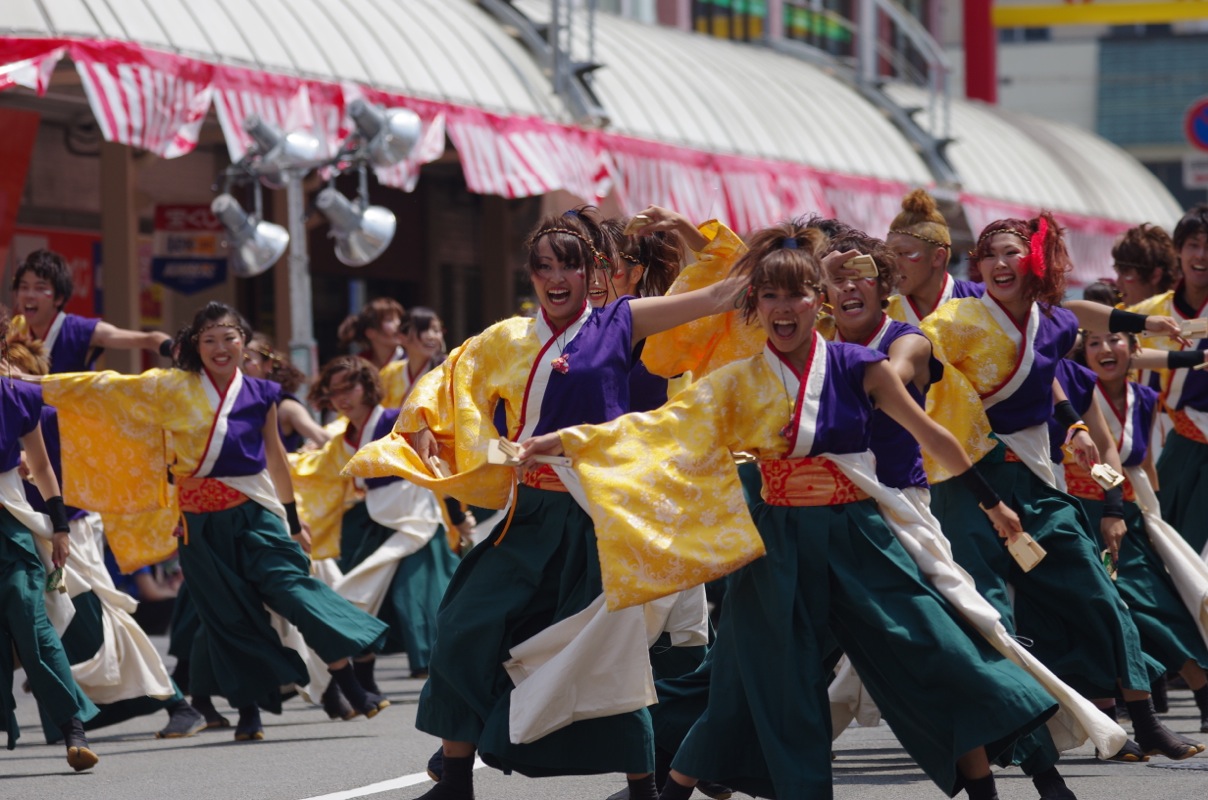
562,355 -> 790,610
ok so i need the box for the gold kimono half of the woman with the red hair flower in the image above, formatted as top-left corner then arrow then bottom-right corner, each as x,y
923,297 -> 1018,483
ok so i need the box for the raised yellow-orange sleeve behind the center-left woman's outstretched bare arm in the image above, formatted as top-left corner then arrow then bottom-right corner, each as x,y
641,221 -> 767,379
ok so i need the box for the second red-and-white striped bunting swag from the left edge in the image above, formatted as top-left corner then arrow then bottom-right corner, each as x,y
70,42 -> 214,158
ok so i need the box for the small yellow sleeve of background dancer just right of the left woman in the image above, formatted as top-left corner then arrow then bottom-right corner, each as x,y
289,436 -> 356,558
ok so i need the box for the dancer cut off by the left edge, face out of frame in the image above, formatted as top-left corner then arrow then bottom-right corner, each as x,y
0,306 -> 99,772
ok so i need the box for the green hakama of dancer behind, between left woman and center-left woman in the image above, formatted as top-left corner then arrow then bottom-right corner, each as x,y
339,503 -> 459,672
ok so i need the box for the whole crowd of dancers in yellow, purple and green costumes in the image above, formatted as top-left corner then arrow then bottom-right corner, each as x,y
0,191 -> 1208,800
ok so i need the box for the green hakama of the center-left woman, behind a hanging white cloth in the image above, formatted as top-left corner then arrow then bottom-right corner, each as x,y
416,486 -> 654,777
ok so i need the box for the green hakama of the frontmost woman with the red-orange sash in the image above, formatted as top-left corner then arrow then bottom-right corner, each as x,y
672,500 -> 1057,800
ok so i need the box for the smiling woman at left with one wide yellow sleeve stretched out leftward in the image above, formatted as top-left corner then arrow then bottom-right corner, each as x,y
27,302 -> 385,741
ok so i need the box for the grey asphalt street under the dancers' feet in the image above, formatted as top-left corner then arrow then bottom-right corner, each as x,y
0,639 -> 1208,800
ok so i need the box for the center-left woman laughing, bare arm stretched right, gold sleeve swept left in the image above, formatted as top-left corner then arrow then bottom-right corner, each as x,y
350,209 -> 748,800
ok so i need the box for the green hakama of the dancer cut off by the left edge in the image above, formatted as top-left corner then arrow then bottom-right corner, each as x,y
0,514 -> 97,750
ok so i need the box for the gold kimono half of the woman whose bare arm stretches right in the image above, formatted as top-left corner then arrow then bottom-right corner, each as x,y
344,317 -> 541,509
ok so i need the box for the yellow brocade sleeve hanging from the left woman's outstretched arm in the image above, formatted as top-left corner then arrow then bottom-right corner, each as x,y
42,370 -> 179,573
